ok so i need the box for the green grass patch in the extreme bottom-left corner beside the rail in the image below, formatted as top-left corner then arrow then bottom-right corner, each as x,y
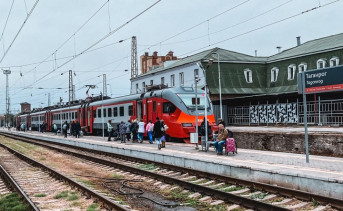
0,193 -> 29,211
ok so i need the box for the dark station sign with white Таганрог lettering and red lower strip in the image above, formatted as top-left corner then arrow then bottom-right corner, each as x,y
298,66 -> 343,94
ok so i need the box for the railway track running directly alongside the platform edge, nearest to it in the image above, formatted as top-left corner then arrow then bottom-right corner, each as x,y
4,134 -> 343,211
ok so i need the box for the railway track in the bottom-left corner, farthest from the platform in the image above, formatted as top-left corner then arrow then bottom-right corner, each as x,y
0,138 -> 130,211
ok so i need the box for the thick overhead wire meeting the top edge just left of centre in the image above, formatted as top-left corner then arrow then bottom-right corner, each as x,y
25,0 -> 162,86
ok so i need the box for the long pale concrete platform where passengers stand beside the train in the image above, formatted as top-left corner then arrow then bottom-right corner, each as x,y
0,127 -> 343,199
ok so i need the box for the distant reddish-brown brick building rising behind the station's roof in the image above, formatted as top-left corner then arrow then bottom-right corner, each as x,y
140,51 -> 177,74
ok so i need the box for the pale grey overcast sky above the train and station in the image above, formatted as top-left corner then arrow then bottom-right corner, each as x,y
0,0 -> 343,113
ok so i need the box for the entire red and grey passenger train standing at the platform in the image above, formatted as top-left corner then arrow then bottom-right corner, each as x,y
18,87 -> 217,142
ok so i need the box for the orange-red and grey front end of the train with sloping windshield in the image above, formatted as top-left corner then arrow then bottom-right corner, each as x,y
161,87 -> 218,143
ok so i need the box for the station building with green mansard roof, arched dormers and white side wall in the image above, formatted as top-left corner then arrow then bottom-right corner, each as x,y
131,33 -> 343,126
